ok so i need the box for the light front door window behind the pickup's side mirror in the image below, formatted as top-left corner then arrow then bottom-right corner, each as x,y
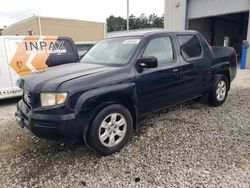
143,37 -> 174,65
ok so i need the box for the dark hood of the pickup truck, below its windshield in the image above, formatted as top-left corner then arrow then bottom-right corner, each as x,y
17,62 -> 116,92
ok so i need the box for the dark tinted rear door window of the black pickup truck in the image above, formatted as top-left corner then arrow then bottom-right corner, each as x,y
177,35 -> 201,60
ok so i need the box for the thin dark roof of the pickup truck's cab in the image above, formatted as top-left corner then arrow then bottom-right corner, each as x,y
107,30 -> 197,38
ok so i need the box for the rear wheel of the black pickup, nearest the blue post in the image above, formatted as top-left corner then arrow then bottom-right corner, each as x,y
208,75 -> 229,107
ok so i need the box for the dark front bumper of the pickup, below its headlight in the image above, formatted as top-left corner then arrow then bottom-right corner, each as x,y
15,100 -> 84,140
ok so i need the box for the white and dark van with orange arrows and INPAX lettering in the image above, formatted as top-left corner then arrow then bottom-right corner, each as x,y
0,36 -> 79,99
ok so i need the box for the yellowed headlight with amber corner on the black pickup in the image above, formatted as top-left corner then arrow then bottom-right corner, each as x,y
40,93 -> 68,107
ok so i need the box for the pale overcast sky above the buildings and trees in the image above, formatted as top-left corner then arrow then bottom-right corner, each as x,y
0,0 -> 164,28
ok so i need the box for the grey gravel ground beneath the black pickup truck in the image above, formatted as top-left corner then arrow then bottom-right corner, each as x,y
0,70 -> 250,187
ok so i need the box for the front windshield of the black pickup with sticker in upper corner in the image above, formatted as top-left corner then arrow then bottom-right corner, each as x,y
81,38 -> 140,65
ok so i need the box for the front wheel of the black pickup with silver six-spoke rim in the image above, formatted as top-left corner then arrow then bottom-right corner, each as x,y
86,104 -> 133,155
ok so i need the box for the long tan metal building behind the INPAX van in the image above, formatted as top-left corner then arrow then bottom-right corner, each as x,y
2,16 -> 107,42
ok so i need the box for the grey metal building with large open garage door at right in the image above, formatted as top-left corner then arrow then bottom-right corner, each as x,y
164,0 -> 250,68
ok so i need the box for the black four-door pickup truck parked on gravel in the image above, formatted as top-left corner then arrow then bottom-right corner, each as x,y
16,31 -> 236,155
